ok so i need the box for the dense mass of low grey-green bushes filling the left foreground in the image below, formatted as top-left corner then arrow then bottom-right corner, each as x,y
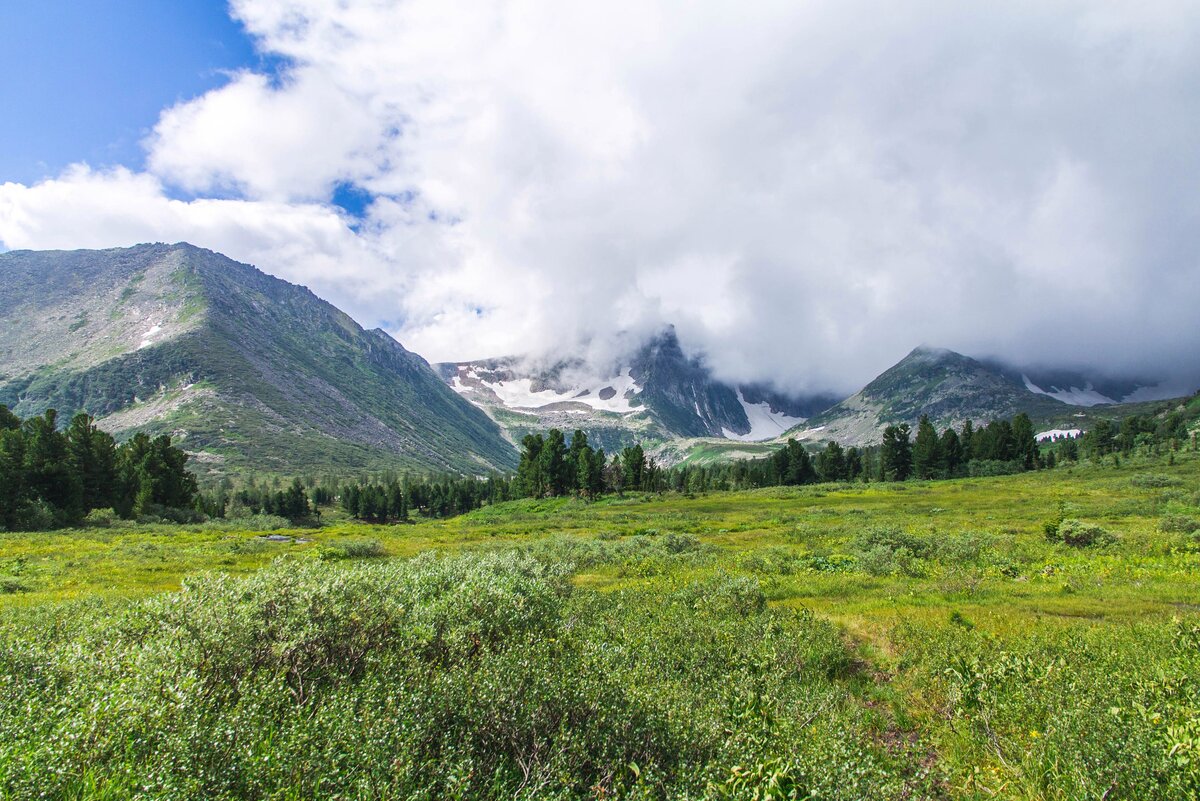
0,553 -> 905,800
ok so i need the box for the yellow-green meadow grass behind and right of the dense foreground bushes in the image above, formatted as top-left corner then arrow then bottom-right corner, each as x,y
0,453 -> 1200,799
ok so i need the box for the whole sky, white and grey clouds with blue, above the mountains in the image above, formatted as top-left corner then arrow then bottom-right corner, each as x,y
0,0 -> 1200,392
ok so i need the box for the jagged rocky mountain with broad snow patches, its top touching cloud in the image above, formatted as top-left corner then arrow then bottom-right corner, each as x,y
436,327 -> 835,450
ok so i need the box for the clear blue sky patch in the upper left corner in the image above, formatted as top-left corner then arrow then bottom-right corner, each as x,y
0,0 -> 263,183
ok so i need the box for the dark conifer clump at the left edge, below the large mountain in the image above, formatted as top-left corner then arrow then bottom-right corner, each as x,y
0,404 -> 197,531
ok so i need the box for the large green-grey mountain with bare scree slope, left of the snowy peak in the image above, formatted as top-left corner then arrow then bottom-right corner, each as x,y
0,243 -> 516,472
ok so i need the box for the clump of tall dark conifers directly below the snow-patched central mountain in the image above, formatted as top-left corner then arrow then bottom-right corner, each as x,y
514,428 -> 665,499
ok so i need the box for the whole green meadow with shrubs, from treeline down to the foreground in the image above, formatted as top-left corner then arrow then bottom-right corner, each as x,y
0,453 -> 1200,800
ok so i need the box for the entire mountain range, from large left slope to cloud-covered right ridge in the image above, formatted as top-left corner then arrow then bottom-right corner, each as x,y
0,243 -> 1185,475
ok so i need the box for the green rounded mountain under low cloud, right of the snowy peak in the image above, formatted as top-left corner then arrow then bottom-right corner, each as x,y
788,345 -> 1176,445
